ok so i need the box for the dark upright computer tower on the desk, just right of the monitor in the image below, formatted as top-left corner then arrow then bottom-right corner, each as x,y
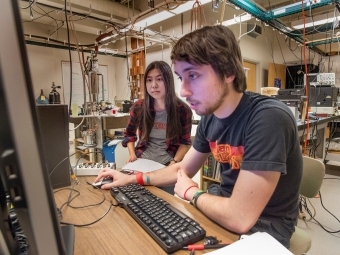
37,104 -> 71,189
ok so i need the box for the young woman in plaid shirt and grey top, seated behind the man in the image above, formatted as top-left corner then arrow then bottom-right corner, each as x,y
122,61 -> 192,194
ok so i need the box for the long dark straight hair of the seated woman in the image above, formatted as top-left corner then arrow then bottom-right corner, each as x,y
137,61 -> 185,141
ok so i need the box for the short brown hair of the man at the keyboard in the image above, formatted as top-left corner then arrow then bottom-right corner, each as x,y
171,25 -> 247,92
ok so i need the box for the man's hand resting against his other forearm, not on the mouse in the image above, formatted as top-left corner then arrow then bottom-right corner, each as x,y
175,169 -> 199,201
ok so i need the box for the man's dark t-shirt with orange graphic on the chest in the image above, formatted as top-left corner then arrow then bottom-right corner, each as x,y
193,92 -> 302,247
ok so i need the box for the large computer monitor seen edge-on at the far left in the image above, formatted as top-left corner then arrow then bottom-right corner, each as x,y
0,0 -> 73,255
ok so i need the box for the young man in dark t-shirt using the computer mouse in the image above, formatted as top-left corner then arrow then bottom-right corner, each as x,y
97,26 -> 302,247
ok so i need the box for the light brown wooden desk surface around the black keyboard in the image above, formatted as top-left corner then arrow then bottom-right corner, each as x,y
55,176 -> 239,255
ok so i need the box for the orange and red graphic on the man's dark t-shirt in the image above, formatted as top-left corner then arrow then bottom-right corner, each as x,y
209,141 -> 244,170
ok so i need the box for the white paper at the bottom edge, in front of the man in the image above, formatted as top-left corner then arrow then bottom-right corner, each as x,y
204,232 -> 294,255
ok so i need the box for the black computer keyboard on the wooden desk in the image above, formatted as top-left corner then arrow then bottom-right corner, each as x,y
111,184 -> 206,253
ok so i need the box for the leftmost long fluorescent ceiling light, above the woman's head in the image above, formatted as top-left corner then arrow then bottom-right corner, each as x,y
134,0 -> 211,28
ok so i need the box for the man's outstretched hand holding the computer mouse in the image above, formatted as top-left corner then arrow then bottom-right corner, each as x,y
94,168 -> 136,189
